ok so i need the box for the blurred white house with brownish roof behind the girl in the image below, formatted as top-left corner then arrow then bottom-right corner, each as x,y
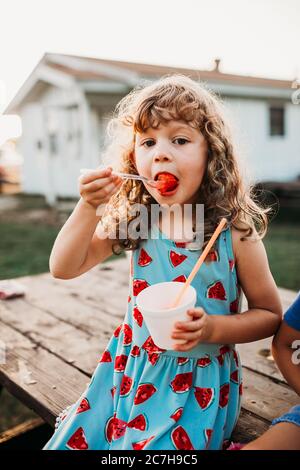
5,53 -> 300,203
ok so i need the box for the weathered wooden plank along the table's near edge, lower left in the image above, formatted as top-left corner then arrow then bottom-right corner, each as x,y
0,321 -> 90,426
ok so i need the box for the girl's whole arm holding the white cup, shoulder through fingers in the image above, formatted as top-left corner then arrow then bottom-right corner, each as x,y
172,226 -> 282,351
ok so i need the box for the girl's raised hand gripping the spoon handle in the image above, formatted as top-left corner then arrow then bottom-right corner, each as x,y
78,167 -> 123,209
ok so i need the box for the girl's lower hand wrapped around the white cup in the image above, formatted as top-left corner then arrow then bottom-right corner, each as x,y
171,307 -> 214,351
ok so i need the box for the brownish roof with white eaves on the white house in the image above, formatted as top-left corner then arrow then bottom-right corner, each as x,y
5,53 -> 293,113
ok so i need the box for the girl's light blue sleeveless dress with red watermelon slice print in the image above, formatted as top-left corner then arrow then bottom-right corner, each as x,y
44,225 -> 242,450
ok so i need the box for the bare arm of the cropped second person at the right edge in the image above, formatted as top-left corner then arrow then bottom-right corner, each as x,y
272,321 -> 300,395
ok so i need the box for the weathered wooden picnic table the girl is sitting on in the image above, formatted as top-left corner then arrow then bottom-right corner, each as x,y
0,257 -> 299,448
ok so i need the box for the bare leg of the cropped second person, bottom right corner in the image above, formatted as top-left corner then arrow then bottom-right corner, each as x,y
241,422 -> 300,450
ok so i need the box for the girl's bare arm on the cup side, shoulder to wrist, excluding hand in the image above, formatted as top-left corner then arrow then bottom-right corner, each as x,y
204,229 -> 282,343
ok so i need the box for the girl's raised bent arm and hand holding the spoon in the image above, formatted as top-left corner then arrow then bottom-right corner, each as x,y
49,167 -> 122,279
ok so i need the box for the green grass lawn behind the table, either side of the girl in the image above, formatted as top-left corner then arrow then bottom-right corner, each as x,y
0,212 -> 300,290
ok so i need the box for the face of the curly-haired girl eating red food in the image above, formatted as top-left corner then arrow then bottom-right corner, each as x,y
135,121 -> 207,205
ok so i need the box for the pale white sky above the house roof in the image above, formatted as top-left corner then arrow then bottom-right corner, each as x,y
0,0 -> 300,141
